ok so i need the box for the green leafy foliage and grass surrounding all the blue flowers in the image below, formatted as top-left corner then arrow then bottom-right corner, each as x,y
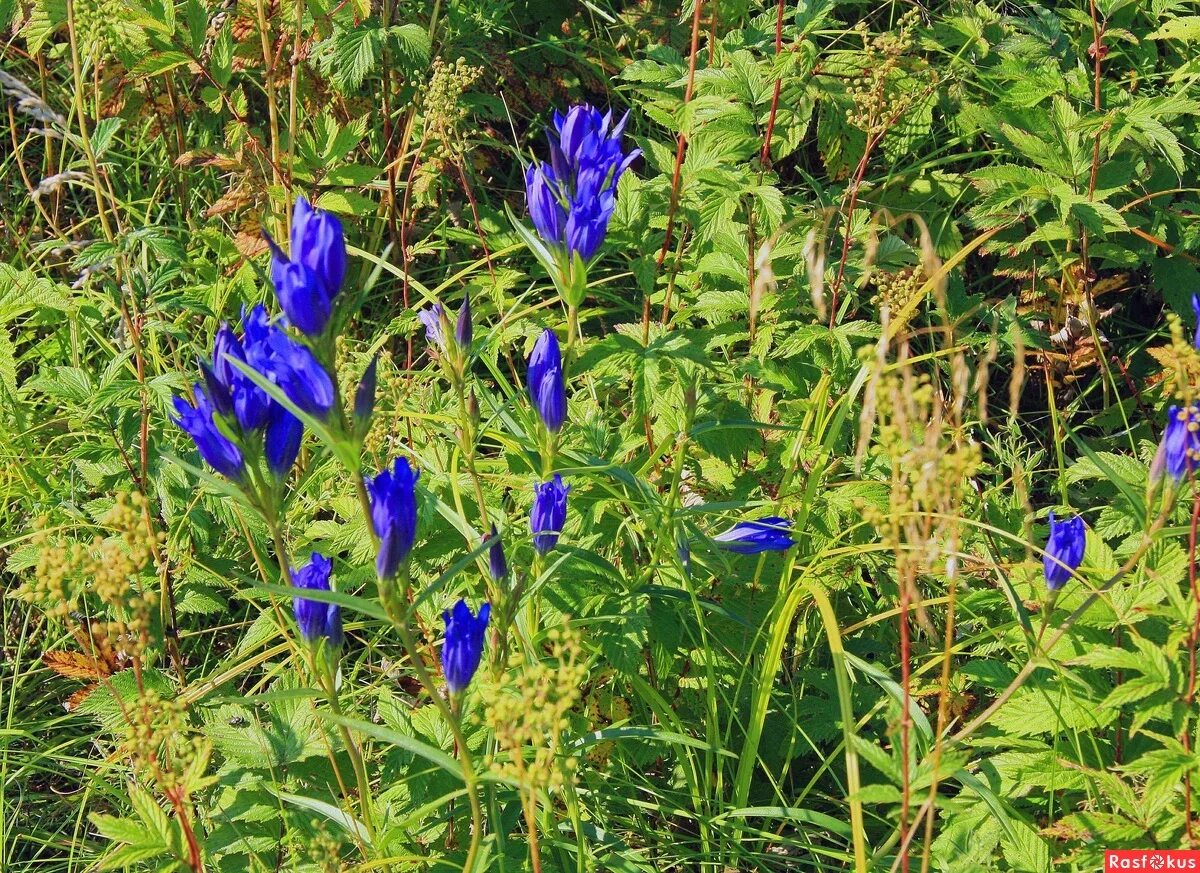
0,0 -> 1200,873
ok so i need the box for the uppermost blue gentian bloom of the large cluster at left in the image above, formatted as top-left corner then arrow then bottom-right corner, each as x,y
266,197 -> 346,337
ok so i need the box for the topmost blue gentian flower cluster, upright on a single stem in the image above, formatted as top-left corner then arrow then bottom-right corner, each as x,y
526,103 -> 641,260
